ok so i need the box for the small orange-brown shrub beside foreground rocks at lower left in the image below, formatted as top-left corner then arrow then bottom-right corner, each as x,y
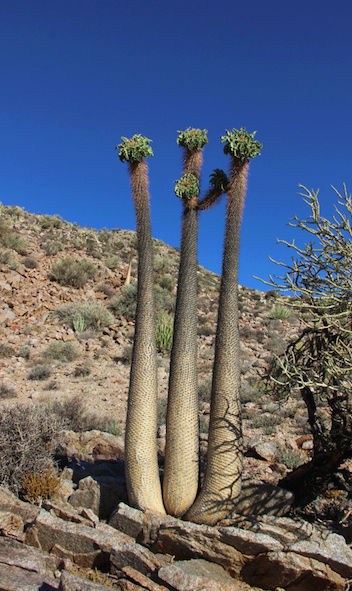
21,468 -> 61,504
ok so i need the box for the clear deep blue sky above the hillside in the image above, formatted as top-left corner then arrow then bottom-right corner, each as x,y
0,0 -> 352,288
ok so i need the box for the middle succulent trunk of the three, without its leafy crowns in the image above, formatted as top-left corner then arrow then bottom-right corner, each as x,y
163,151 -> 202,515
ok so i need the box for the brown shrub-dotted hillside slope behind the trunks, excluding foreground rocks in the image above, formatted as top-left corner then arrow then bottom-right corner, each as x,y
0,206 -> 308,462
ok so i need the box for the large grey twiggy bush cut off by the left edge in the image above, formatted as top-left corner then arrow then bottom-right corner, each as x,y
0,404 -> 62,494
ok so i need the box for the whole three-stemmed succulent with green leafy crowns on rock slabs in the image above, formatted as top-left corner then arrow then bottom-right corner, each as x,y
117,127 -> 261,525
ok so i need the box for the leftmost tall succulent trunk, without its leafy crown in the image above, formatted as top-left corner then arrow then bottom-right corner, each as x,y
125,161 -> 165,513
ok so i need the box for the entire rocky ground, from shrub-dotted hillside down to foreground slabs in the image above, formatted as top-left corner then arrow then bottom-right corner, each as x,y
0,206 -> 352,591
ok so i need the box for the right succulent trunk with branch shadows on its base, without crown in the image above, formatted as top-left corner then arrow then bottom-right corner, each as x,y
186,158 -> 248,525
